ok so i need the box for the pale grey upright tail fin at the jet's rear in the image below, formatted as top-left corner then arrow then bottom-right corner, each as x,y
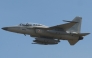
68,16 -> 82,33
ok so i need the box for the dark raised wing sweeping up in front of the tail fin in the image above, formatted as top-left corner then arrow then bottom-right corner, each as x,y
49,22 -> 76,30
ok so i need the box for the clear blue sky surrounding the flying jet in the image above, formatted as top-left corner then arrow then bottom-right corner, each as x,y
0,0 -> 92,58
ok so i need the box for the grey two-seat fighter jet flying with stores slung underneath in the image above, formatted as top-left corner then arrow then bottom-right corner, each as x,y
2,16 -> 90,45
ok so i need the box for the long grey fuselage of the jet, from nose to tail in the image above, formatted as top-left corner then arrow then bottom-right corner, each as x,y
1,26 -> 78,40
